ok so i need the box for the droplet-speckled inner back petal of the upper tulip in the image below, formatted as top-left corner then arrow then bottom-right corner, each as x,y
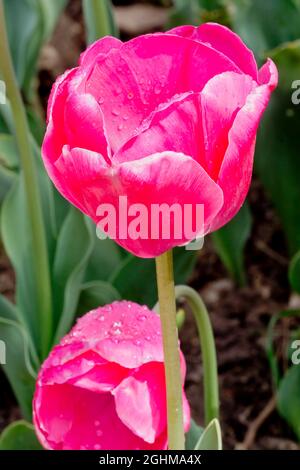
86,34 -> 239,152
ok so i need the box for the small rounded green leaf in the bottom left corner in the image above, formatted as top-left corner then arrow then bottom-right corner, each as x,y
0,420 -> 43,450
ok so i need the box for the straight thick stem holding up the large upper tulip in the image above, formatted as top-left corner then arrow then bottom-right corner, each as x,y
156,251 -> 184,450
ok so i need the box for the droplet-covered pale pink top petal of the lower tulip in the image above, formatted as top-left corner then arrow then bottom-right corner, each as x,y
67,302 -> 163,368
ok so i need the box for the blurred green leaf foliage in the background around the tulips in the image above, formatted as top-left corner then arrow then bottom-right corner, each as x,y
0,0 -> 300,448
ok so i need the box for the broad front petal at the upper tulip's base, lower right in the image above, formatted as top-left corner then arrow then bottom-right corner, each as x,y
108,152 -> 223,258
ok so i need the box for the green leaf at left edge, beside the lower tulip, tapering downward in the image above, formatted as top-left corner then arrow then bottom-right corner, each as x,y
0,317 -> 36,419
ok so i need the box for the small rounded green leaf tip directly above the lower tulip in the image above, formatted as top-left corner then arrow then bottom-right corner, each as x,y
76,281 -> 121,316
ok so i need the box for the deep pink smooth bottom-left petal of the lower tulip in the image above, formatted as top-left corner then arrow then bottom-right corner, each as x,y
34,385 -> 159,450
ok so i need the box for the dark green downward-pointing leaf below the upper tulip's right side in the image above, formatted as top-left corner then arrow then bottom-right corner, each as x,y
212,203 -> 252,285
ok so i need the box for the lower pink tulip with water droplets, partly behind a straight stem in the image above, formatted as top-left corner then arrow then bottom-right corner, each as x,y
33,301 -> 190,450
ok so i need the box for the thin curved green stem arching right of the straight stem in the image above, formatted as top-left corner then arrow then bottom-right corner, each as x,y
175,286 -> 219,425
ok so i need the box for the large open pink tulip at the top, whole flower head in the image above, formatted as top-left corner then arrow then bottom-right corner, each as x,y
43,23 -> 277,257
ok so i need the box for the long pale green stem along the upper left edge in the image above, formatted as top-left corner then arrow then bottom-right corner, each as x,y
0,0 -> 52,356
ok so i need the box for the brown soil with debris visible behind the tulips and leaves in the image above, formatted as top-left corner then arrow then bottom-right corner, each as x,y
0,0 -> 299,449
